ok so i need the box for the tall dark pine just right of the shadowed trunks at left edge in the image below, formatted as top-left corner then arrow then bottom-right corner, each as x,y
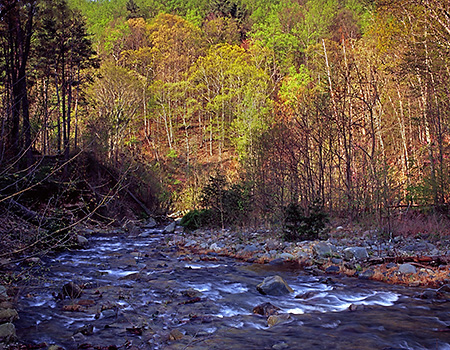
36,0 -> 96,160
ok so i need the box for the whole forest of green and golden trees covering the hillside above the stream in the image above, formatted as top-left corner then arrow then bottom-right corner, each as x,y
0,0 -> 450,235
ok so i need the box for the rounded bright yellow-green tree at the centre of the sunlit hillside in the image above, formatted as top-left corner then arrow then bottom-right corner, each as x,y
190,44 -> 270,159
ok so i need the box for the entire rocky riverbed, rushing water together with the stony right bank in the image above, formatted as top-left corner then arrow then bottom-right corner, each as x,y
0,223 -> 450,349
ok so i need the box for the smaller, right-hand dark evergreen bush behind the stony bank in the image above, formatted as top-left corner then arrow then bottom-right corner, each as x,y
283,203 -> 328,242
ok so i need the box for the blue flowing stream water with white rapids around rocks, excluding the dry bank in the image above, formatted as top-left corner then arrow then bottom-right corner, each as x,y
16,231 -> 450,350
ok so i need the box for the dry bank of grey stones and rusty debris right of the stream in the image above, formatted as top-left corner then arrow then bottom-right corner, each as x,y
160,225 -> 450,287
